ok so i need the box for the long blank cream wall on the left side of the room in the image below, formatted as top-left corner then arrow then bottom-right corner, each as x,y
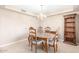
0,9 -> 38,45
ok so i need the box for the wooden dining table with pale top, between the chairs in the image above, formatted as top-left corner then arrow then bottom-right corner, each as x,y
36,31 -> 56,52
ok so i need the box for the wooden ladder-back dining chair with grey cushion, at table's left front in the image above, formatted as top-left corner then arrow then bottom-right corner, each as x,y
29,27 -> 43,52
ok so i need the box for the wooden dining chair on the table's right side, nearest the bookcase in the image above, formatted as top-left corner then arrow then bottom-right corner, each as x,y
48,31 -> 58,53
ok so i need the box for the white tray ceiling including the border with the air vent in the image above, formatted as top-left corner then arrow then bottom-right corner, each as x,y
6,4 -> 73,15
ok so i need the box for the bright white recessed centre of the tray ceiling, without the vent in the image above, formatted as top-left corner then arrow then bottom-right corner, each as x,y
15,5 -> 72,14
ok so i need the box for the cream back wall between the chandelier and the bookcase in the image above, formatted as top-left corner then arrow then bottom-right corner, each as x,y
42,15 -> 64,40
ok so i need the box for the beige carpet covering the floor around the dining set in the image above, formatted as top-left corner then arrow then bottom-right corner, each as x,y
0,39 -> 79,53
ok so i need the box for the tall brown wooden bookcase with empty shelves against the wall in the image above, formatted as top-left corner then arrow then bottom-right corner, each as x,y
64,14 -> 76,45
